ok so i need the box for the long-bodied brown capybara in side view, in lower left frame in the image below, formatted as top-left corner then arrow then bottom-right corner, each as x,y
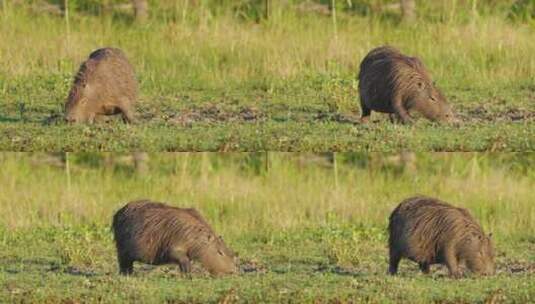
112,200 -> 236,275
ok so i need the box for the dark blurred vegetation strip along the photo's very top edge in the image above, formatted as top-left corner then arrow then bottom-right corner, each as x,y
8,0 -> 535,22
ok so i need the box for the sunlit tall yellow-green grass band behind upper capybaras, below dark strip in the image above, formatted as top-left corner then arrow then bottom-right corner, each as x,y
0,8 -> 535,92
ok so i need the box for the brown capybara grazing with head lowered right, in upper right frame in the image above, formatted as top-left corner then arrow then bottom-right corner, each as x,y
358,46 -> 456,123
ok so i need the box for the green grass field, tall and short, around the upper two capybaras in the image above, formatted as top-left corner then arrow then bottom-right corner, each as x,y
0,1 -> 535,151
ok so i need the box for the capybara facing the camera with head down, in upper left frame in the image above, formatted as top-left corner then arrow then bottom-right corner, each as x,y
65,48 -> 138,122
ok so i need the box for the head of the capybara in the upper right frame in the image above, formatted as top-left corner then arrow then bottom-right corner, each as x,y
408,81 -> 456,123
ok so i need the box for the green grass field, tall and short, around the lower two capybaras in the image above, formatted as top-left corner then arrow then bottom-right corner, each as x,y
0,153 -> 535,303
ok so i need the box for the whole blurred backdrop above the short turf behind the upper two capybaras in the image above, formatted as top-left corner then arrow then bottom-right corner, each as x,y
4,0 -> 535,94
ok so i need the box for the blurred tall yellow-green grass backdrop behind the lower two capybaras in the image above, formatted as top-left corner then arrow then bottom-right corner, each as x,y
0,152 -> 535,237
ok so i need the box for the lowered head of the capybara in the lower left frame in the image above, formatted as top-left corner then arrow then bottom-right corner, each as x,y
199,235 -> 237,276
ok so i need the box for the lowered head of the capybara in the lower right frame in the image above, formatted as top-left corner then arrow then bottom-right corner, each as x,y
459,234 -> 496,275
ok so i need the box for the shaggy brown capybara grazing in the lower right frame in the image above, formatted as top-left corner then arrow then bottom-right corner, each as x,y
388,196 -> 494,278
